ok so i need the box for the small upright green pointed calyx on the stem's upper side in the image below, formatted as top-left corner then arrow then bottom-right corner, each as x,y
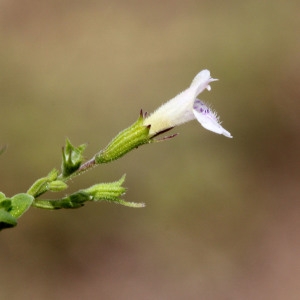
61,139 -> 86,177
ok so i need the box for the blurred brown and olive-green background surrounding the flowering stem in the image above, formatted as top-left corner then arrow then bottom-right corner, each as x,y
0,0 -> 300,300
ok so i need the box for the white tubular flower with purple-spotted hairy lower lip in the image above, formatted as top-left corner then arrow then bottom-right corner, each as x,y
144,70 -> 232,138
